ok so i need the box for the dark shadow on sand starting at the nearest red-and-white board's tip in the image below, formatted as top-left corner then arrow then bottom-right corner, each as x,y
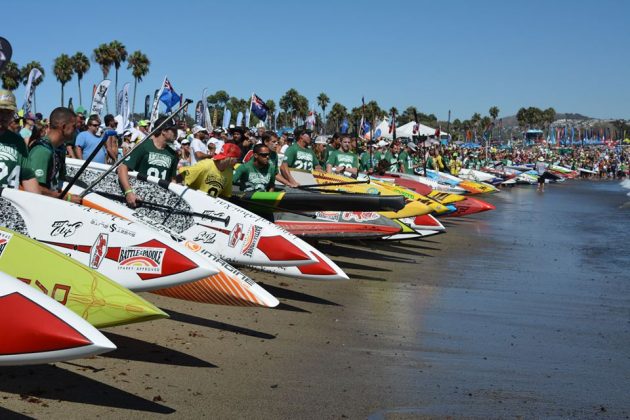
102,332 -> 217,368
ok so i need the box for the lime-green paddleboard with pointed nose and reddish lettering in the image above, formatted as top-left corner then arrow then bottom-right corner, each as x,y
0,227 -> 168,328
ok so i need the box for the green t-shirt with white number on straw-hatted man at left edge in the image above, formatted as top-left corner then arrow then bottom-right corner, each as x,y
0,130 -> 35,188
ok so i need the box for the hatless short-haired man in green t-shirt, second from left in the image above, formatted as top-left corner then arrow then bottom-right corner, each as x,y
28,107 -> 81,204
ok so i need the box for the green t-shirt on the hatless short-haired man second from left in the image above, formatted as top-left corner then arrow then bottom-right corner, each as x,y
28,137 -> 66,191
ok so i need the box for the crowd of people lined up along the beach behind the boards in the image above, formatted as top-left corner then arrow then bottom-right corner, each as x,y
0,91 -> 630,207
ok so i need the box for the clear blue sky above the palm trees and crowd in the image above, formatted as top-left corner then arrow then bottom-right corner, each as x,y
0,0 -> 630,119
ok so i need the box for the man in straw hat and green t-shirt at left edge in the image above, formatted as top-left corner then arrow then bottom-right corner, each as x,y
0,90 -> 39,193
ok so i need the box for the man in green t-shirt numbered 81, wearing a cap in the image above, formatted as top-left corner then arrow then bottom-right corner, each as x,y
118,117 -> 178,208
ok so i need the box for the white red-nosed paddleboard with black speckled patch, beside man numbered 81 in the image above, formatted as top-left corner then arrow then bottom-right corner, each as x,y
67,159 -> 314,266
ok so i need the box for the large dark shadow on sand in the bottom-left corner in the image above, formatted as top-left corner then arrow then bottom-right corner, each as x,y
0,365 -> 175,418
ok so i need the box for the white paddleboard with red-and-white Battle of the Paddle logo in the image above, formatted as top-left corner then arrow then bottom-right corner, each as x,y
0,188 -> 217,291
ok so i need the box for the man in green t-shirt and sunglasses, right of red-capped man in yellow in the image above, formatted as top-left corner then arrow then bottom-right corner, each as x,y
232,144 -> 278,191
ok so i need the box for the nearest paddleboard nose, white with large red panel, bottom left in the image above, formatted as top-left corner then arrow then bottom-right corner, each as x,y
0,272 -> 116,366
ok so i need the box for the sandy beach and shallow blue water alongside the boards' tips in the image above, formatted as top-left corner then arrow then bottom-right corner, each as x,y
0,181 -> 630,419
